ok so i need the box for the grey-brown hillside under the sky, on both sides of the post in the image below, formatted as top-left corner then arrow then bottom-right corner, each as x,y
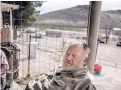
36,5 -> 121,28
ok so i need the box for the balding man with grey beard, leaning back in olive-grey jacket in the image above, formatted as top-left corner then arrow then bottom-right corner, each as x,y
26,43 -> 96,90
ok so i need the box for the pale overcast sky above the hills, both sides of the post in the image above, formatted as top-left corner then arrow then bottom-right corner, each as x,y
37,0 -> 121,14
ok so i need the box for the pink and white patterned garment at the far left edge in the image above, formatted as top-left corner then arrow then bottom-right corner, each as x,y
0,49 -> 9,79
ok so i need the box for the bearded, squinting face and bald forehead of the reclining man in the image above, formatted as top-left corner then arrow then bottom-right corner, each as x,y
63,46 -> 85,70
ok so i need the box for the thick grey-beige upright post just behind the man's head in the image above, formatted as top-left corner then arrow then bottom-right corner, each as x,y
87,1 -> 102,73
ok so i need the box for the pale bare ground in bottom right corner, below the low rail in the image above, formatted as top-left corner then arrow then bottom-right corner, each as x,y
94,66 -> 121,90
